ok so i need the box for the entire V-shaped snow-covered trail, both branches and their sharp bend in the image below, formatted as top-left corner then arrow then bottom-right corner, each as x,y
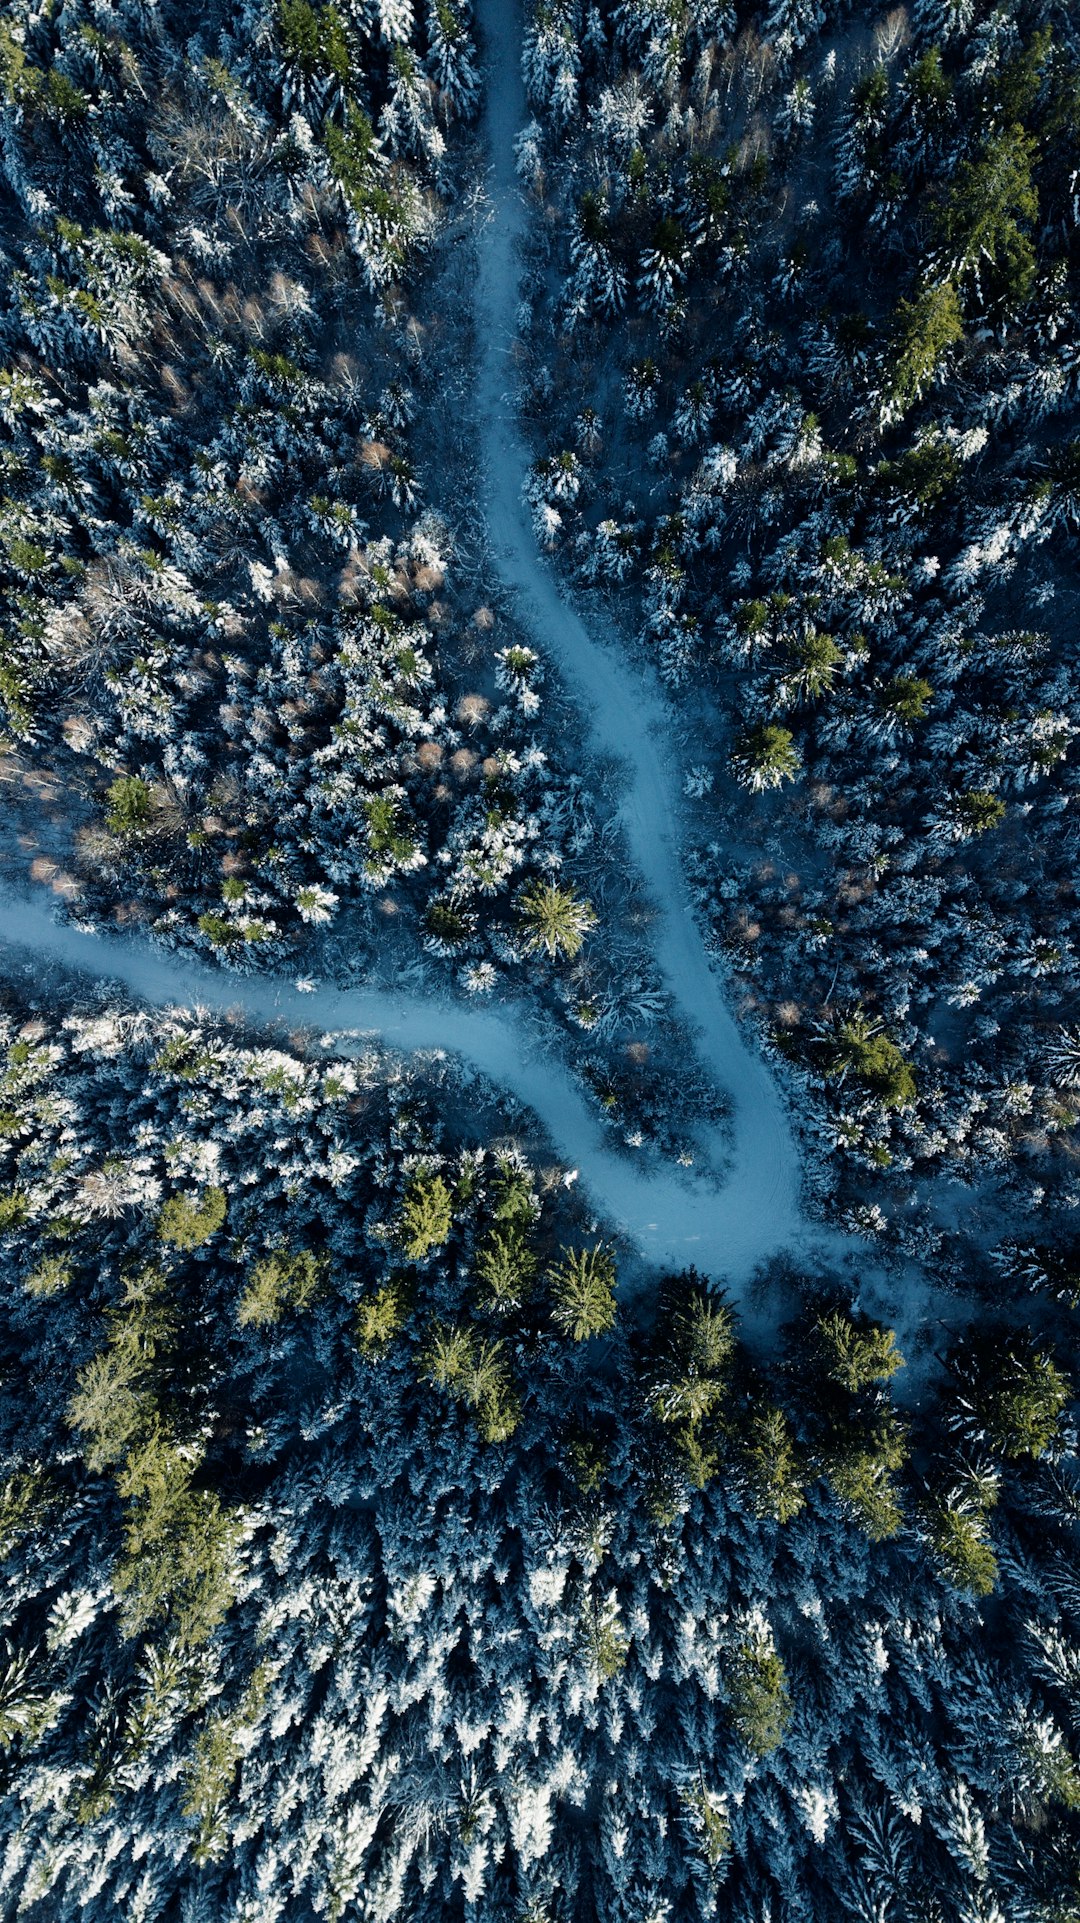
0,0 -> 841,1288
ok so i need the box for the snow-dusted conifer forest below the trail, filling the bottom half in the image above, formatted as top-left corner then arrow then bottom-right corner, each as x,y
0,996 -> 1080,1923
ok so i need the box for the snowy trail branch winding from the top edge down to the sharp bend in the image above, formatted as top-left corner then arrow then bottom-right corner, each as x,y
475,0 -> 801,1256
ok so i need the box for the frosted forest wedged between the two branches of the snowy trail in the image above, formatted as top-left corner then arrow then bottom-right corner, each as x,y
0,0 -> 622,1015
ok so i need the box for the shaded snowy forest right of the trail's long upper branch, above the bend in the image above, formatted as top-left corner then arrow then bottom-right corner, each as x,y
507,0 -> 1080,1246
